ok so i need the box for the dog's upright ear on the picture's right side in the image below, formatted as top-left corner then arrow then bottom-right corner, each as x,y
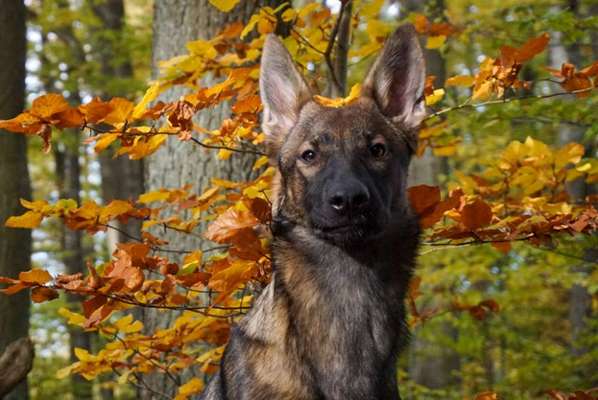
362,24 -> 426,141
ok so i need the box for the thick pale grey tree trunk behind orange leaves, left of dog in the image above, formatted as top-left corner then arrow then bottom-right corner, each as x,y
141,0 -> 283,399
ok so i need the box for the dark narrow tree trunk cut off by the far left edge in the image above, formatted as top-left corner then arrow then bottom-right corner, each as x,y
0,0 -> 31,400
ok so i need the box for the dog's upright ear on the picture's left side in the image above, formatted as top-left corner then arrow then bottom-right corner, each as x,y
260,34 -> 312,150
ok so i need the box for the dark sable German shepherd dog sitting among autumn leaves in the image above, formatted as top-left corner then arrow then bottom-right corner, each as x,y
202,25 -> 425,400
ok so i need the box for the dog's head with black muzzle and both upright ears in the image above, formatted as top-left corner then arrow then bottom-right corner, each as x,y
260,25 -> 425,244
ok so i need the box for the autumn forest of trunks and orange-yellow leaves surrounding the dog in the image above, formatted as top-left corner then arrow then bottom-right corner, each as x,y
0,0 -> 598,399
